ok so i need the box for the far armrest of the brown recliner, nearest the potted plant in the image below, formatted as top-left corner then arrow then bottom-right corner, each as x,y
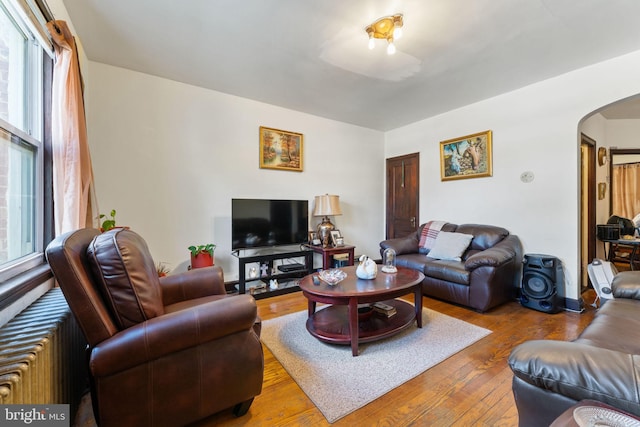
160,266 -> 226,306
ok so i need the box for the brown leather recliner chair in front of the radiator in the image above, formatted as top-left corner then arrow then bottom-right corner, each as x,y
46,229 -> 264,427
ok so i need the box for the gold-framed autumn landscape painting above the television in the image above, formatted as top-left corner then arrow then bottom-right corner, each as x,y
260,126 -> 303,172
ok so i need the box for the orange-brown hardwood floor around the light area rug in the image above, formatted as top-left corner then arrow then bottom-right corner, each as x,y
198,291 -> 595,427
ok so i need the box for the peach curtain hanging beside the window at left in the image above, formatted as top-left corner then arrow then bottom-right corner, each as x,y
47,21 -> 97,235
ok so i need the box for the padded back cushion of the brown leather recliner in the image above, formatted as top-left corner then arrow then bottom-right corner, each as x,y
87,228 -> 164,329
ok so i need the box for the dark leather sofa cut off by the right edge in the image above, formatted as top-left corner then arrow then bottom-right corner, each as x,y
509,271 -> 640,427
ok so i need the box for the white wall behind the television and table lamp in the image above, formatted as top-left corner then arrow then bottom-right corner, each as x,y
88,62 -> 384,280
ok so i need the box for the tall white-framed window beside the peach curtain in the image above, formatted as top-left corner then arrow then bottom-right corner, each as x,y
0,0 -> 50,294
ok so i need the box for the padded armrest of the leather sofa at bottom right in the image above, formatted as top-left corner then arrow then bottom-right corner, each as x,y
509,340 -> 640,413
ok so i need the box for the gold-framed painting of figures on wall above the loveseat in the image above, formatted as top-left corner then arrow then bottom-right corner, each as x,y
440,130 -> 493,181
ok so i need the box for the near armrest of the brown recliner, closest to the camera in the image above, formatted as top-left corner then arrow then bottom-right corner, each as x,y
90,295 -> 258,377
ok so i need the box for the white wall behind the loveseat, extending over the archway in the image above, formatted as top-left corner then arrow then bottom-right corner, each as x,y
385,52 -> 640,299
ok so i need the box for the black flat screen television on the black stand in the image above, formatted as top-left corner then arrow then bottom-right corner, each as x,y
231,199 -> 309,250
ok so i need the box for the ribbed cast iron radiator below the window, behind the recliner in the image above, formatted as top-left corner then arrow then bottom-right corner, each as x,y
0,288 -> 87,414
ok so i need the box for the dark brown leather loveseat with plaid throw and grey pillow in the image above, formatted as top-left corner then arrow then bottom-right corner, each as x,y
380,223 -> 522,312
